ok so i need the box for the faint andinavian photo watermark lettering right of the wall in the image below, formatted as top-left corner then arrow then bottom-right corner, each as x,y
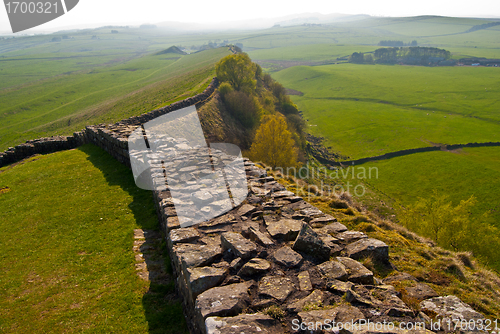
274,162 -> 379,197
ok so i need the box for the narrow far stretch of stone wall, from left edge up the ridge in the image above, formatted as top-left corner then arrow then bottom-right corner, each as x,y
0,78 -> 218,167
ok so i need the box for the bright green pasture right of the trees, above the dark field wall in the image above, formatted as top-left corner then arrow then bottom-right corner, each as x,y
273,64 -> 500,159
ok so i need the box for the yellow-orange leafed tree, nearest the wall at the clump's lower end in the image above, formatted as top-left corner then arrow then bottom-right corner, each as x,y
250,114 -> 297,168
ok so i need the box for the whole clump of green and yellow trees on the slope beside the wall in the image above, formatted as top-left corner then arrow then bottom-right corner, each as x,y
215,53 -> 306,168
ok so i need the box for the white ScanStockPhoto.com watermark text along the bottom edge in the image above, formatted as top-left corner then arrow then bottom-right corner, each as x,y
292,319 -> 426,333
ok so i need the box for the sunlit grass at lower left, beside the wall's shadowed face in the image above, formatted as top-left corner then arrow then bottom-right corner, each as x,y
0,145 -> 187,333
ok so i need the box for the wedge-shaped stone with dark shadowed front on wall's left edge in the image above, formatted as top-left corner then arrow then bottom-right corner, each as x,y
186,267 -> 228,301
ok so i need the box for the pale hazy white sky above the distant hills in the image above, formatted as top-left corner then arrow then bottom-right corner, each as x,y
0,0 -> 500,33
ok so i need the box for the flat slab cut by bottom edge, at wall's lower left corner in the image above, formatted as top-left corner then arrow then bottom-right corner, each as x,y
205,313 -> 284,334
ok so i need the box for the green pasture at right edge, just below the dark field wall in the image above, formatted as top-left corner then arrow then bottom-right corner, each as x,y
362,147 -> 500,227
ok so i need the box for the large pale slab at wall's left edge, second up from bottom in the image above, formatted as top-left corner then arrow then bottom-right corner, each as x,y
195,281 -> 254,320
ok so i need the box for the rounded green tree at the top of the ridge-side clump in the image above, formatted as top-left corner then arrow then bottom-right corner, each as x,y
215,53 -> 257,93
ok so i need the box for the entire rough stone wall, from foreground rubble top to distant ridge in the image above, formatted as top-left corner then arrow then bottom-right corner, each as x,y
0,76 -> 483,334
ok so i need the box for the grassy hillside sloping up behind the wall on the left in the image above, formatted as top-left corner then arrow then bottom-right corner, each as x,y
0,49 -> 228,150
